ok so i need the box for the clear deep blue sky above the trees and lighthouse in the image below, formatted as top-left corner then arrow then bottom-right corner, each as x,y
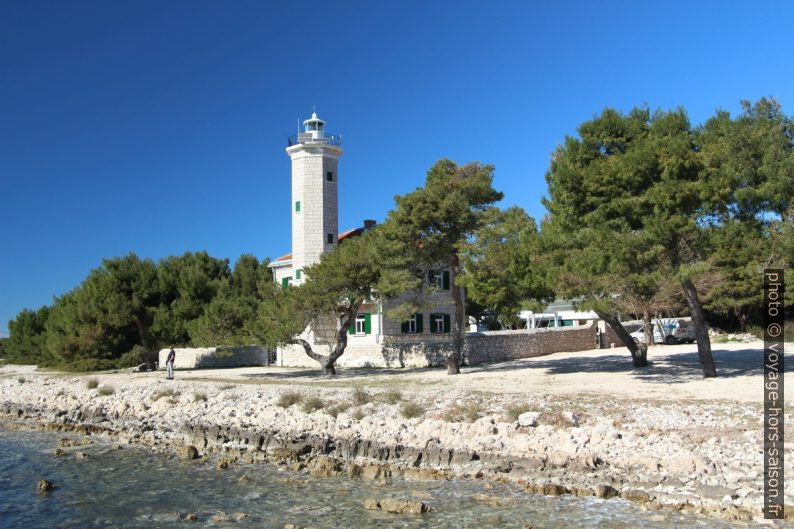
0,0 -> 794,334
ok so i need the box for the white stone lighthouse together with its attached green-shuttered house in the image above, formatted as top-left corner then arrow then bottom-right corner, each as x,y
269,113 -> 454,366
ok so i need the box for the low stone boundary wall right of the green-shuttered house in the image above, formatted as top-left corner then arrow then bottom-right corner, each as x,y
466,322 -> 597,365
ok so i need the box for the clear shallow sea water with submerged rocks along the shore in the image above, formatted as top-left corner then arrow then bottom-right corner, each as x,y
0,429 -> 747,529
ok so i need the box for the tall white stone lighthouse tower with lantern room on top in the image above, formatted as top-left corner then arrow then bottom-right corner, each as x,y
287,112 -> 342,283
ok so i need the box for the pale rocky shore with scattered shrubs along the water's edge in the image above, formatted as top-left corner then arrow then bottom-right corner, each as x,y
0,366 -> 794,524
